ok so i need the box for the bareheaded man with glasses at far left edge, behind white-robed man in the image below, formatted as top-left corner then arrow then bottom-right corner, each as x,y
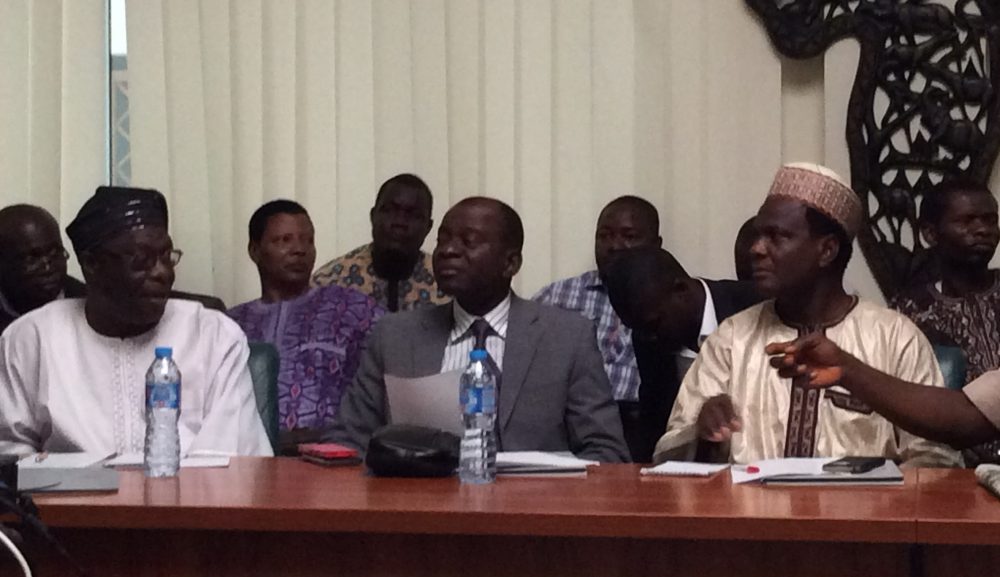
0,204 -> 85,333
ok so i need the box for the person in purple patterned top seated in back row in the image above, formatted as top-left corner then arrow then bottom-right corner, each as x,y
229,200 -> 385,441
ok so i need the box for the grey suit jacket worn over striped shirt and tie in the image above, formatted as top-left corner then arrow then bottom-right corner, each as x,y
324,296 -> 628,463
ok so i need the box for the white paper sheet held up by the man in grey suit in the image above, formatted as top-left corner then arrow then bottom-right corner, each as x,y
385,371 -> 462,436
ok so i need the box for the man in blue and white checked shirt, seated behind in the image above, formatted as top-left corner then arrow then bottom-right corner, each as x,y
534,196 -> 663,457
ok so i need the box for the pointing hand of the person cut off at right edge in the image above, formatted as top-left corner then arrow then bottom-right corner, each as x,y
765,333 -> 849,388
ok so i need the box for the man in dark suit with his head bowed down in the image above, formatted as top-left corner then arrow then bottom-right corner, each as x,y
603,248 -> 762,461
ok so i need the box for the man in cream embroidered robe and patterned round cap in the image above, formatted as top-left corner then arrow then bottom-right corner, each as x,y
655,164 -> 961,466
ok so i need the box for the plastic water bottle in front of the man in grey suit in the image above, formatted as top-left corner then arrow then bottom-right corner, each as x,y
458,349 -> 497,484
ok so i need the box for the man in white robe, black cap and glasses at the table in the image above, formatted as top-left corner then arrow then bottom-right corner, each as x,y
0,187 -> 271,455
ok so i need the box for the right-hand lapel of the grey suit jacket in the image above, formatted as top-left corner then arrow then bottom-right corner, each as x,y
499,295 -> 542,431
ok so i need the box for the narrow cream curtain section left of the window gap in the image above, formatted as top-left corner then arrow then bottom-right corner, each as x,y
0,0 -> 108,270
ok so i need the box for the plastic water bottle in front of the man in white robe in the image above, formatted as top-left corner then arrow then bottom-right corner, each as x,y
143,347 -> 181,477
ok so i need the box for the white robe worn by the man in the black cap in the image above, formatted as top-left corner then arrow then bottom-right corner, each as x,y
0,299 -> 272,456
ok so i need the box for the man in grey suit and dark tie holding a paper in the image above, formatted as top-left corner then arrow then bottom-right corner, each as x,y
327,197 -> 629,463
